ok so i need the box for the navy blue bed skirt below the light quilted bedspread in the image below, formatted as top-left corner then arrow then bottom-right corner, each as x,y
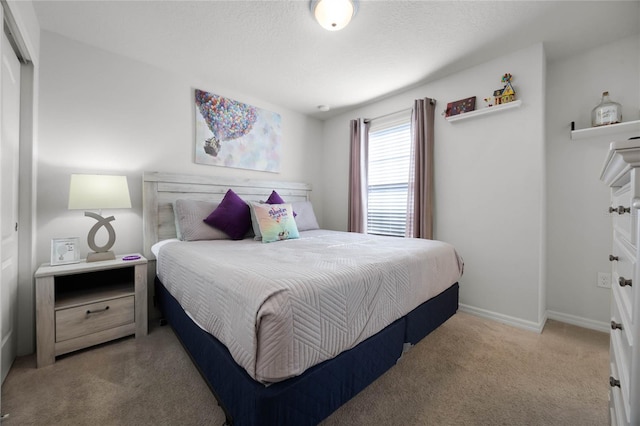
156,278 -> 458,426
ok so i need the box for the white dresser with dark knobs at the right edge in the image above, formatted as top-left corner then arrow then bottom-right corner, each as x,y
600,139 -> 640,426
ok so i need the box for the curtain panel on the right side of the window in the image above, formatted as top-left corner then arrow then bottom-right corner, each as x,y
405,98 -> 436,239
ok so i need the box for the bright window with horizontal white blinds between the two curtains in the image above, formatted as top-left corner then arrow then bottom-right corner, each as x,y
367,111 -> 411,237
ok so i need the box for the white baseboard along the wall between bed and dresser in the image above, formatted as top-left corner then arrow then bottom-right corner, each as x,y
458,303 -> 610,333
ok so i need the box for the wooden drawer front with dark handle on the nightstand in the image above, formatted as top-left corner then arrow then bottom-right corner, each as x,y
55,296 -> 135,342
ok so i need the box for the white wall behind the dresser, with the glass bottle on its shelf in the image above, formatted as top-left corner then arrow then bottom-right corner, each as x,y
546,36 -> 640,328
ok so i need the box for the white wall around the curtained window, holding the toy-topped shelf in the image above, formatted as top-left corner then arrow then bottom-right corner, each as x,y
323,44 -> 545,329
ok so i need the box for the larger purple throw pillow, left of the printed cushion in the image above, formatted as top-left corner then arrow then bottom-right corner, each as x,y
204,189 -> 251,240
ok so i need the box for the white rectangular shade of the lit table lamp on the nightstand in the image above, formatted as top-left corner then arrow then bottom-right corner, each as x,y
69,175 -> 131,210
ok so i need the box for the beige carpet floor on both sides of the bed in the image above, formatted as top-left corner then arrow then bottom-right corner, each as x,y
1,313 -> 609,426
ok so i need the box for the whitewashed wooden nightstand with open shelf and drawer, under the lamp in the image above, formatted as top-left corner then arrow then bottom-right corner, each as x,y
35,255 -> 148,367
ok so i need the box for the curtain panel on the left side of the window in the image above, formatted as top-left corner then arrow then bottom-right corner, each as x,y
347,119 -> 369,234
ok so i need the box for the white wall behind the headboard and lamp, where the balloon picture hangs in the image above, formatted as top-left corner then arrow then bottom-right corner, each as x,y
37,31 -> 322,262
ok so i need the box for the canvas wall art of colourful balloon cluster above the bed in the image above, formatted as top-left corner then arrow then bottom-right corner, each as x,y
195,89 -> 282,173
